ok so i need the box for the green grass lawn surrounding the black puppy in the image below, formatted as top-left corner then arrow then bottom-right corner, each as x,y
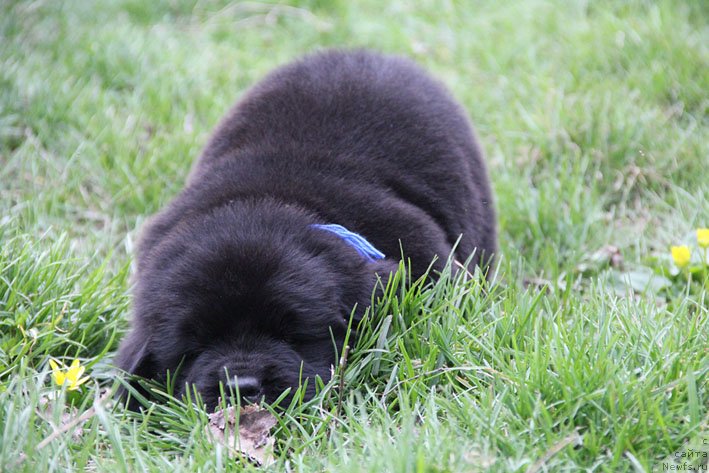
0,0 -> 709,472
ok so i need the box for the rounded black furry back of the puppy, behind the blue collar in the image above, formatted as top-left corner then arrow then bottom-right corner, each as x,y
159,51 -> 496,272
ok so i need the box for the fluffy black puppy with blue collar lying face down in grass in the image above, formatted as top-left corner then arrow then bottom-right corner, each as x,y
117,51 -> 496,406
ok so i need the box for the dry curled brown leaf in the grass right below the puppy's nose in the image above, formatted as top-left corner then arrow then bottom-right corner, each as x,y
207,405 -> 276,466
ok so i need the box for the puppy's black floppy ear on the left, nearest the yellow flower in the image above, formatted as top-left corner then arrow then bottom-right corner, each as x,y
116,331 -> 156,411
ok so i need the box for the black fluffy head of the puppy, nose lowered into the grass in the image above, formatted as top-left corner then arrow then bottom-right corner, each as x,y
118,202 -> 393,407
